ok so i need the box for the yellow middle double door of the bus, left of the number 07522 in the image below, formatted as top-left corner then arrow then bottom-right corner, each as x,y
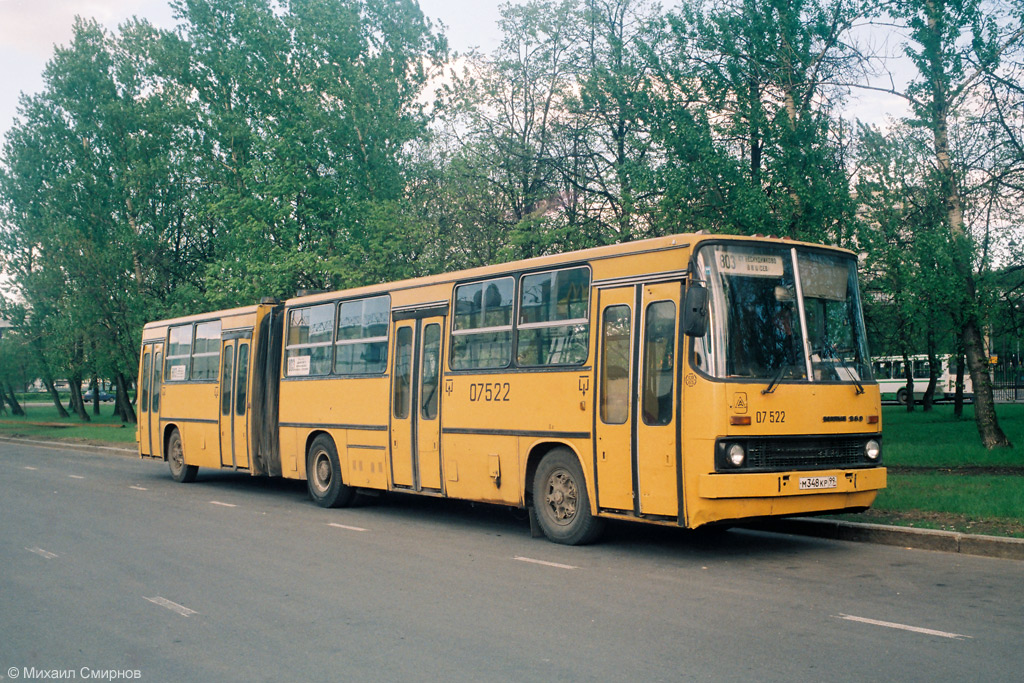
391,316 -> 444,490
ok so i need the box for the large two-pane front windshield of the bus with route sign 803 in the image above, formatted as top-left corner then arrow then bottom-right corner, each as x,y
694,244 -> 871,386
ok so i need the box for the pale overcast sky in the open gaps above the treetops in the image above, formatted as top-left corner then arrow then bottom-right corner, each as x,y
0,0 -> 898,143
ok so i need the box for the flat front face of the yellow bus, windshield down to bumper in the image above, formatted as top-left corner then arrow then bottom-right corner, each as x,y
683,239 -> 886,526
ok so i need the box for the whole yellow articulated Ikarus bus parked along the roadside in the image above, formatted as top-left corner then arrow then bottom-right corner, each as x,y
137,234 -> 886,544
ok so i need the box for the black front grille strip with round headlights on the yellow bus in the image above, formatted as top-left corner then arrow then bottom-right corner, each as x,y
743,437 -> 868,471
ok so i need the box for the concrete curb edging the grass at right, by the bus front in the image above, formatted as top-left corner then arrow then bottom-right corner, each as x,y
744,517 -> 1024,560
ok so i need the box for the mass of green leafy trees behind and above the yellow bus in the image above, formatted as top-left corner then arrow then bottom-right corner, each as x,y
0,0 -> 1024,450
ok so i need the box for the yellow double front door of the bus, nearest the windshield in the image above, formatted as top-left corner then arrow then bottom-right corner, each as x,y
594,283 -> 682,517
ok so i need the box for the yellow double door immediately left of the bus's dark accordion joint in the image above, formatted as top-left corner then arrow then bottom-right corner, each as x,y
219,338 -> 251,469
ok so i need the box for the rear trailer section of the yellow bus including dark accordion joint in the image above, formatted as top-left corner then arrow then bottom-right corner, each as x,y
136,303 -> 281,481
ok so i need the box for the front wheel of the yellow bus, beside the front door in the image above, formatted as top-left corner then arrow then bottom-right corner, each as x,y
534,449 -> 604,546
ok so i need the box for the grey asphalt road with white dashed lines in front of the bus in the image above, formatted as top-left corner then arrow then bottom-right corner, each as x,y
0,441 -> 1024,681
